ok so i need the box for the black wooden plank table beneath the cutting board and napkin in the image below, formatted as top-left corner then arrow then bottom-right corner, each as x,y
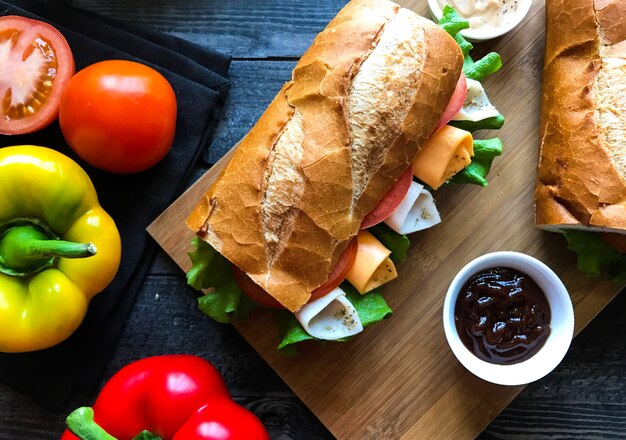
0,0 -> 626,440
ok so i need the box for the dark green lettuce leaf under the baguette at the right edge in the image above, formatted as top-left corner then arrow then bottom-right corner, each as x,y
563,230 -> 626,284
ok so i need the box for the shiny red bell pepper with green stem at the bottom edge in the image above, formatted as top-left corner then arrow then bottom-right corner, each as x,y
61,355 -> 269,440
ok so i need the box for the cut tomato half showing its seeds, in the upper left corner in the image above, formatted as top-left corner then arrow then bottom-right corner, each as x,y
0,16 -> 74,134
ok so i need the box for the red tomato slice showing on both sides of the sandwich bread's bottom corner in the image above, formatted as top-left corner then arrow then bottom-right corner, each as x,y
232,239 -> 358,309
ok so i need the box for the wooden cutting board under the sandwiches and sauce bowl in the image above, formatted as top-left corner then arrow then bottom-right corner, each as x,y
148,0 -> 620,439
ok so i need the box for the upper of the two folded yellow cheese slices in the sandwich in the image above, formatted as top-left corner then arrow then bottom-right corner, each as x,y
412,125 -> 474,189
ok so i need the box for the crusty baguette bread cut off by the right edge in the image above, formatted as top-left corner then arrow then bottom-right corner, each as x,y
535,0 -> 626,234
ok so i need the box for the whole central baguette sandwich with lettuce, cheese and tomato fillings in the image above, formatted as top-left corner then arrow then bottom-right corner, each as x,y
187,0 -> 503,346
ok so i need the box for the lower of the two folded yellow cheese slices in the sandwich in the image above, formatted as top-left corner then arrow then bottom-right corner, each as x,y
346,230 -> 398,293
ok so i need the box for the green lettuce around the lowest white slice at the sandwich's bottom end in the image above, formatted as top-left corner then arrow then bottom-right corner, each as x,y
276,282 -> 393,355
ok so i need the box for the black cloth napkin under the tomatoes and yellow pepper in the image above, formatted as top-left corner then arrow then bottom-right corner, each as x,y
0,0 -> 230,411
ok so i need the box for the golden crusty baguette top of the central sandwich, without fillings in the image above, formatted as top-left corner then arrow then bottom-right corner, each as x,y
187,0 -> 463,311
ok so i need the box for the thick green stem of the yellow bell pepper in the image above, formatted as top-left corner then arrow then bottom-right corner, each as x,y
0,224 -> 96,275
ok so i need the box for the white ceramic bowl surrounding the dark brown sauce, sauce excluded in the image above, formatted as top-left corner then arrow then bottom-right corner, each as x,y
443,252 -> 574,385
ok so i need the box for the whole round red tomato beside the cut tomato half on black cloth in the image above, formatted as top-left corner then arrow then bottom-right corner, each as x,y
59,60 -> 176,174
